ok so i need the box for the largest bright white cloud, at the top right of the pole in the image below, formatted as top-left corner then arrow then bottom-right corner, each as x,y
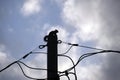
62,0 -> 100,41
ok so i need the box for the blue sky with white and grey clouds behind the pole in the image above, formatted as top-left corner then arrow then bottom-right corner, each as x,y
0,0 -> 120,80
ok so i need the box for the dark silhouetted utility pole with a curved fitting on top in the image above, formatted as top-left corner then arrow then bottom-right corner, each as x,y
44,30 -> 59,80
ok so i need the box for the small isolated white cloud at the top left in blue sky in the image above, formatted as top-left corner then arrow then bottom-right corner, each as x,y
21,0 -> 41,16
